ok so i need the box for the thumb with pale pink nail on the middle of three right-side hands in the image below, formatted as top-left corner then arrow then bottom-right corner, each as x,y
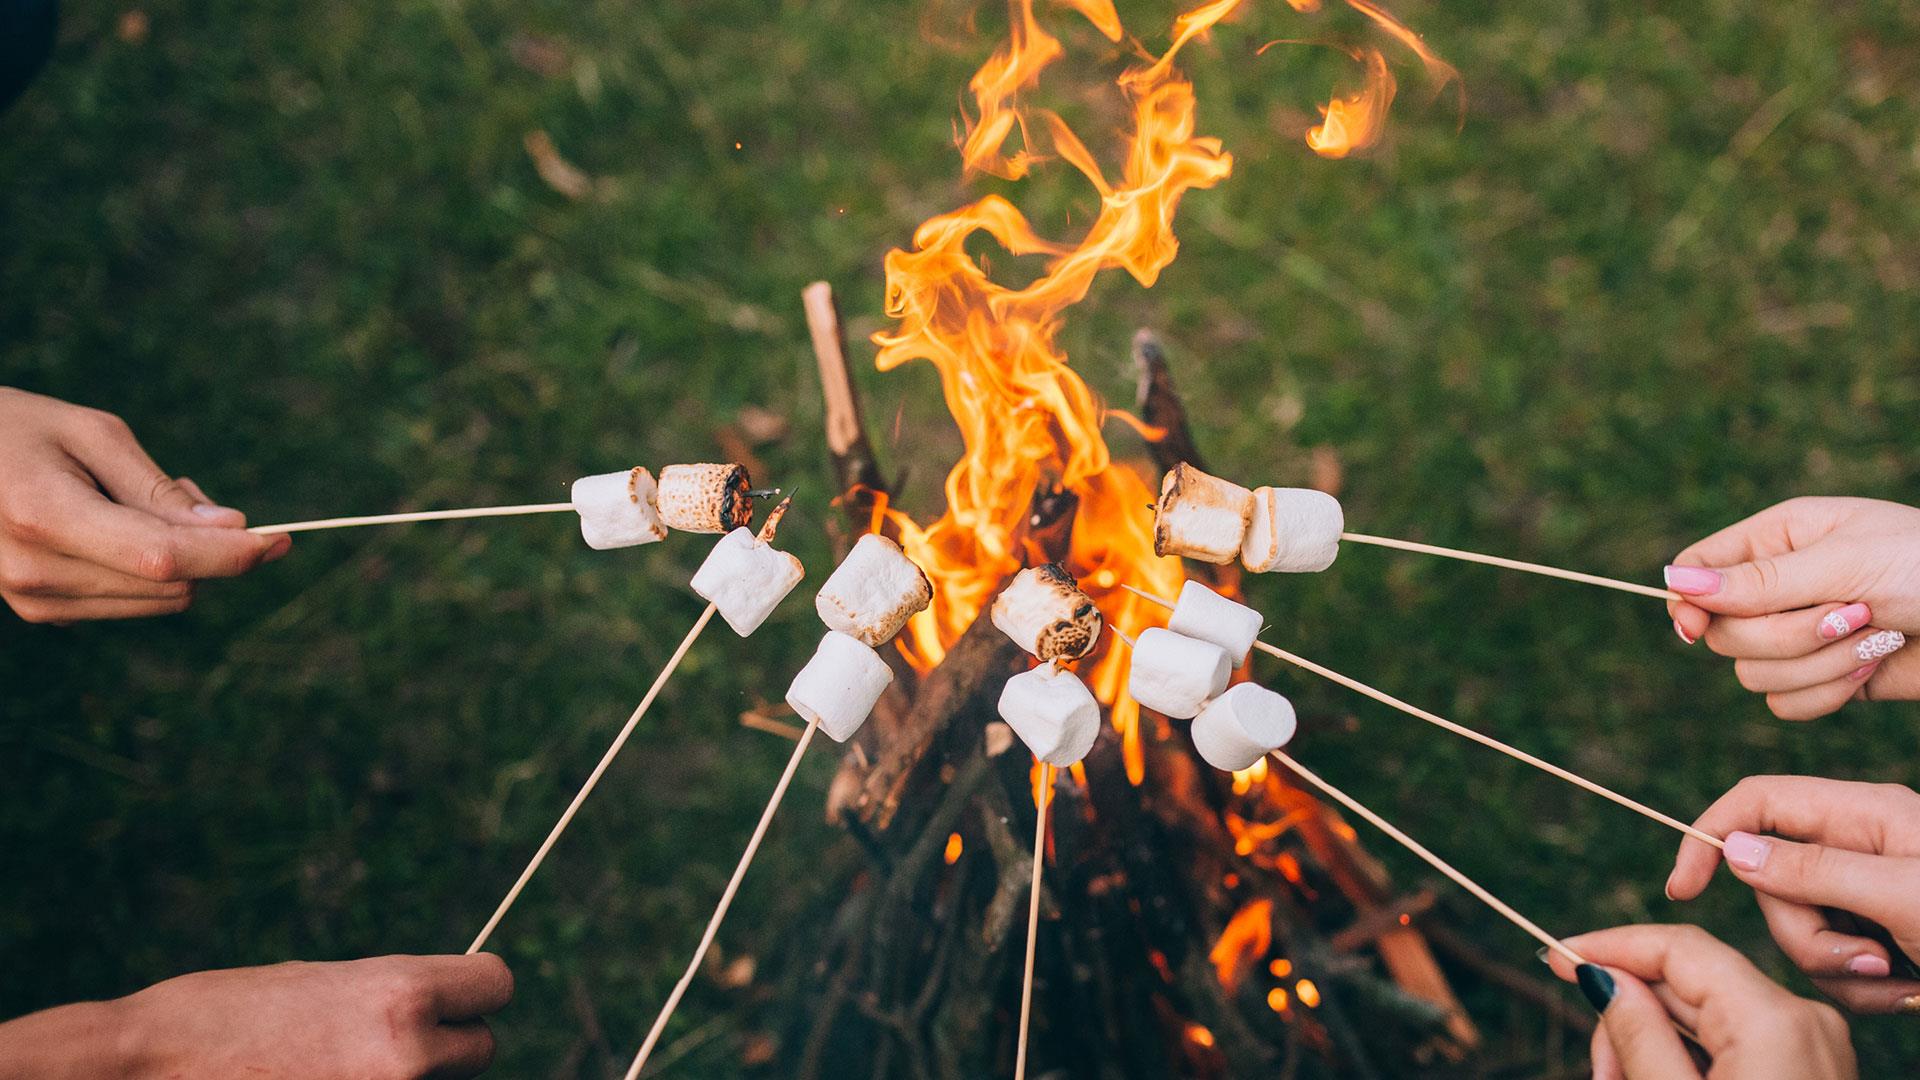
1724,832 -> 1920,934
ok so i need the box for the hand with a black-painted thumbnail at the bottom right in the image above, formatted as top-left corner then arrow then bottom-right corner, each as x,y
1548,914 -> 1857,1080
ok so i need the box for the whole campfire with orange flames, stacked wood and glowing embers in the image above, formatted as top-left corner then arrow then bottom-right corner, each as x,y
748,0 -> 1590,1078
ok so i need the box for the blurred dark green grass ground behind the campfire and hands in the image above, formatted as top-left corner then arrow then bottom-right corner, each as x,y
0,0 -> 1920,1076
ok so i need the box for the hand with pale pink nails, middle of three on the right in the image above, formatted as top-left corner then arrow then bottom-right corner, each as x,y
1667,776 -> 1920,1013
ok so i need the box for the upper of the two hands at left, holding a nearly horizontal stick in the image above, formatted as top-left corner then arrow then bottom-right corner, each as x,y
0,386 -> 292,623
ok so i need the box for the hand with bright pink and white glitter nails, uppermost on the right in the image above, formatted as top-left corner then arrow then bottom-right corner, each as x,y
1667,498 -> 1920,721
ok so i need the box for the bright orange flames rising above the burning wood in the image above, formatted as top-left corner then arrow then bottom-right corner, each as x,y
874,0 -> 1452,786
